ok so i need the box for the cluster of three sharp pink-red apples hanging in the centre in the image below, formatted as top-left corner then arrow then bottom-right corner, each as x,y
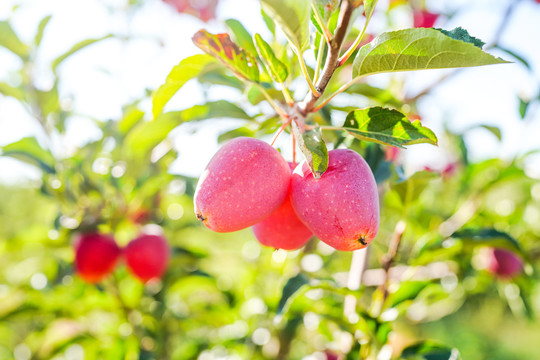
195,137 -> 379,251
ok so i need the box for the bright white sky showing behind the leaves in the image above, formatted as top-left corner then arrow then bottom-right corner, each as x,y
0,0 -> 540,182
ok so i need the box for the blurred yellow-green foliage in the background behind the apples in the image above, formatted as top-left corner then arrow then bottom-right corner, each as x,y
0,1 -> 540,360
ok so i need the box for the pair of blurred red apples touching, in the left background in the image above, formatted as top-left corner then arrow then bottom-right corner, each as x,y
75,232 -> 170,283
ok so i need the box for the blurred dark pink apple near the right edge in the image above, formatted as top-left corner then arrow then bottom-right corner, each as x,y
482,247 -> 523,279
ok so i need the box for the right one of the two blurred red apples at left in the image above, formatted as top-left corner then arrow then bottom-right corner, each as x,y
124,234 -> 170,282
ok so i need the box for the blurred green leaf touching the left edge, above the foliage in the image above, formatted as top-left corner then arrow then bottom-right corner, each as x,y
0,137 -> 56,174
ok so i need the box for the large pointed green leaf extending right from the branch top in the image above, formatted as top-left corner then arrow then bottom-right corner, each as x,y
353,28 -> 507,78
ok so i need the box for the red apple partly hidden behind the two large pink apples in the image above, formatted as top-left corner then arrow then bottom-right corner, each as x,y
252,163 -> 313,250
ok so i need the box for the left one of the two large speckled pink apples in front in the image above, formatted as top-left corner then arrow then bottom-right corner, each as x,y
194,137 -> 291,232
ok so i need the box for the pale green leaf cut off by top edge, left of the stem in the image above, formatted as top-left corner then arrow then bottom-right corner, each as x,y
261,0 -> 311,53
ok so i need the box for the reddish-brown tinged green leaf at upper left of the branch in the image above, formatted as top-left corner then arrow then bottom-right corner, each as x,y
193,30 -> 259,82
